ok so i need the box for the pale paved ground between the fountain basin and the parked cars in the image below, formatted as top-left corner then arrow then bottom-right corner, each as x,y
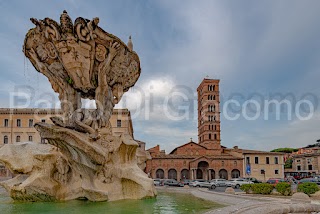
157,187 -> 320,214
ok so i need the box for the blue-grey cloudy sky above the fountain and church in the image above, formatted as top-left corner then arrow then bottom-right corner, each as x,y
0,0 -> 320,152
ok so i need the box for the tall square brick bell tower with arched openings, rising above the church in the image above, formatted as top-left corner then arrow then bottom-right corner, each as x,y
197,78 -> 221,149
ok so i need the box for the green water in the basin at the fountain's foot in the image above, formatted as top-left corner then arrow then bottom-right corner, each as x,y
0,190 -> 221,214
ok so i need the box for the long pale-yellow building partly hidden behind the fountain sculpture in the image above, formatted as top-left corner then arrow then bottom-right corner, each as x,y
0,108 -> 150,177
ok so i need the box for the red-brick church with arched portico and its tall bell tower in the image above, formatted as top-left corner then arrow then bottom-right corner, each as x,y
146,79 -> 244,180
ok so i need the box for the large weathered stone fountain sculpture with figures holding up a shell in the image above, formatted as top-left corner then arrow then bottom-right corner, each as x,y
0,11 -> 156,201
